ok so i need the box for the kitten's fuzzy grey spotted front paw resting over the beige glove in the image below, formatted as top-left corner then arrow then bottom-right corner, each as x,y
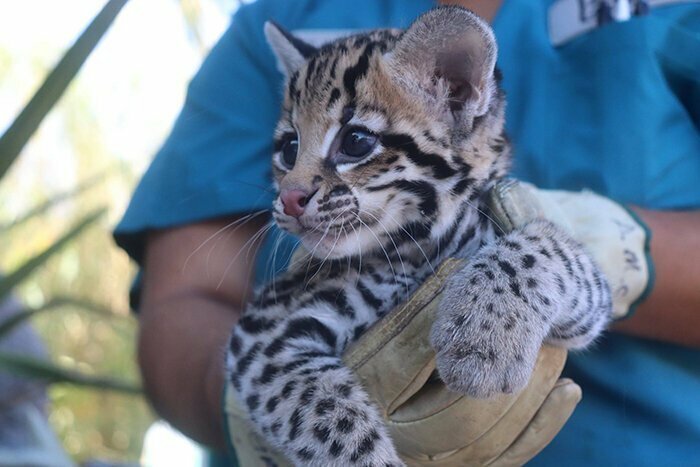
431,267 -> 544,398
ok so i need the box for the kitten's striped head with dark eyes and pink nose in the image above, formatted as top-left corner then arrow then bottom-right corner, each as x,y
265,7 -> 508,258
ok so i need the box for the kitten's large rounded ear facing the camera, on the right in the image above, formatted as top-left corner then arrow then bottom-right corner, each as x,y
388,6 -> 497,119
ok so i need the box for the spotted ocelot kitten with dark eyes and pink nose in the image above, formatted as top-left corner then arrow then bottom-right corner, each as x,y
228,7 -> 611,467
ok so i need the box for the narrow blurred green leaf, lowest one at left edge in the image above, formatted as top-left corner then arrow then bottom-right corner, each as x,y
0,352 -> 142,395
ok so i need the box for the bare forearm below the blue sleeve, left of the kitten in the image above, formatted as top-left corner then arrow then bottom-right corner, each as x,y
138,219 -> 262,449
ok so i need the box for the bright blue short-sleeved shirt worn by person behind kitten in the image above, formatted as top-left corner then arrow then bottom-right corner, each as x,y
115,0 -> 700,466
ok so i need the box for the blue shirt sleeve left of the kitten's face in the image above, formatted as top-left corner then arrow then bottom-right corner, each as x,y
114,2 -> 282,264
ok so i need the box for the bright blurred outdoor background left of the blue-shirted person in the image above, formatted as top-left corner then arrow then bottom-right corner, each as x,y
0,0 -> 246,465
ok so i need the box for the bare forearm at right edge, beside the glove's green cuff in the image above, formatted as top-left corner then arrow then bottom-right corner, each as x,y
613,209 -> 700,347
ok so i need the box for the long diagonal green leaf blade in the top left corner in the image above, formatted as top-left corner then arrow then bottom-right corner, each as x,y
0,0 -> 127,179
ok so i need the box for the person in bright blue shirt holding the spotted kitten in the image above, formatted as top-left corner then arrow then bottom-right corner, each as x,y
116,0 -> 700,465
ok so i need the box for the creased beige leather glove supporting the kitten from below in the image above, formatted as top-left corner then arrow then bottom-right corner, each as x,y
225,260 -> 581,467
